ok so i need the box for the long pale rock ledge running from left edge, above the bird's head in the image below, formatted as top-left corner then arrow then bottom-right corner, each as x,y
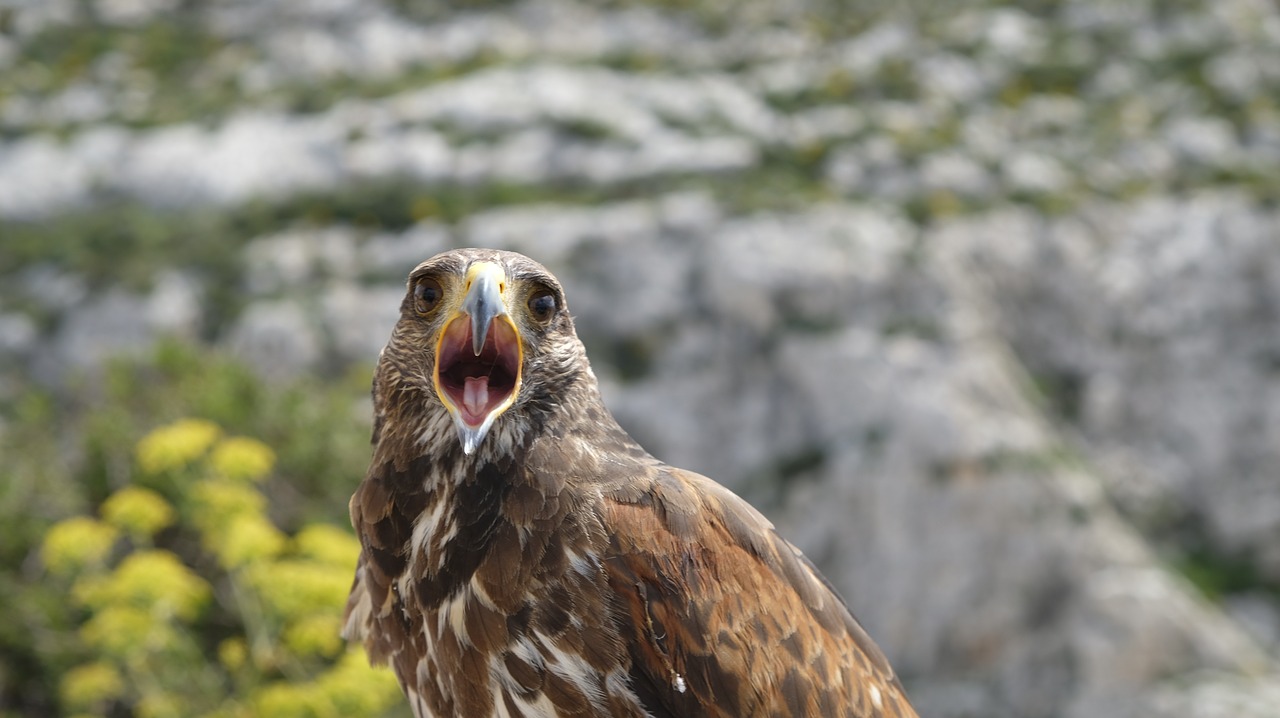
0,65 -> 783,218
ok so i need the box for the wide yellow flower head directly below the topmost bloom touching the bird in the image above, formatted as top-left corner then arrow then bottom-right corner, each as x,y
246,561 -> 351,619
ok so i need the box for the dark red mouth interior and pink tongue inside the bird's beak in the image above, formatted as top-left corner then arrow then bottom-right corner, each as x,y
436,316 -> 520,426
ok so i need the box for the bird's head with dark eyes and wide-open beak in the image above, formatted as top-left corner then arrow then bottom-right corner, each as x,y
383,250 -> 586,454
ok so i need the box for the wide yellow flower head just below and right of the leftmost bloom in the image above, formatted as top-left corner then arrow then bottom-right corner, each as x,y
74,550 -> 211,621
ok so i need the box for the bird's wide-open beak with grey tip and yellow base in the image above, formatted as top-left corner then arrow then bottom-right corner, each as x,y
433,262 -> 524,454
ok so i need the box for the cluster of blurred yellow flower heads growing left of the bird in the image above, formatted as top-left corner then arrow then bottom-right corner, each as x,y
41,419 -> 402,718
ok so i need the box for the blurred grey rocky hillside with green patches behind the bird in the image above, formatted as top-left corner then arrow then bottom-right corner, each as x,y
0,0 -> 1280,718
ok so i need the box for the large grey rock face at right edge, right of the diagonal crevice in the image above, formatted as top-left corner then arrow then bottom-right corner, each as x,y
937,195 -> 1280,591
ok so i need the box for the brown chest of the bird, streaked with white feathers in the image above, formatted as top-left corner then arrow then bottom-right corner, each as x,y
398,471 -> 645,718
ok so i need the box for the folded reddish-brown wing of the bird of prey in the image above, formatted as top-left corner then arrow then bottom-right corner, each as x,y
604,467 -> 915,718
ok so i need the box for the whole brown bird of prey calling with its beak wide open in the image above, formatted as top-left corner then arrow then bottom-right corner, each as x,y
343,248 -> 916,718
